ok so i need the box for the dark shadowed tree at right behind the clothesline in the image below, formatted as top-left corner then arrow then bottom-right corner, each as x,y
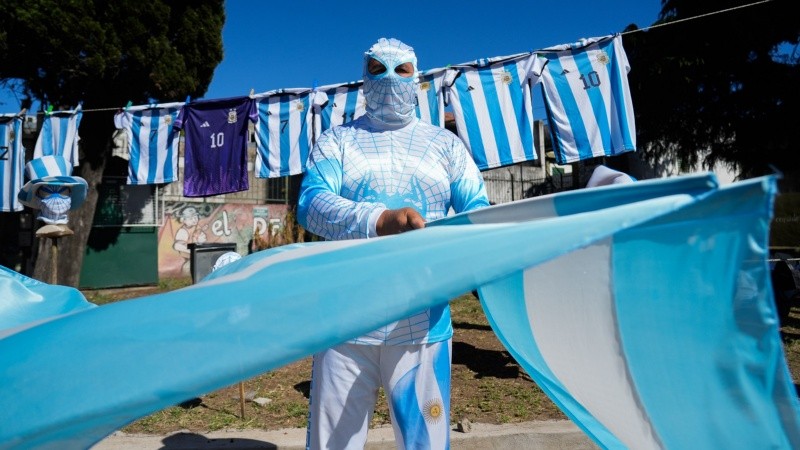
623,0 -> 800,191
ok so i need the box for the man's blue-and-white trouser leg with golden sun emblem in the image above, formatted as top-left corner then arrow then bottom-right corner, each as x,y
381,339 -> 452,449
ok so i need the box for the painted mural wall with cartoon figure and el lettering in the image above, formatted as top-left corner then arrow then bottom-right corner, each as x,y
158,202 -> 287,278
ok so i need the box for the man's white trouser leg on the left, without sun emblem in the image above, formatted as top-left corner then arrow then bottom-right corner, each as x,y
306,344 -> 380,450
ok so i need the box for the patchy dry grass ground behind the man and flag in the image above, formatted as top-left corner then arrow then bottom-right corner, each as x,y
79,279 -> 800,435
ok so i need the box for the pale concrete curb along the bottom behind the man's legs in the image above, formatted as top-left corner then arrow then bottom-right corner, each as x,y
91,420 -> 598,450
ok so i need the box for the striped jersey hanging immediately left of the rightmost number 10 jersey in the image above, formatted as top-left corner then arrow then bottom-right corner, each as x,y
445,53 -> 538,170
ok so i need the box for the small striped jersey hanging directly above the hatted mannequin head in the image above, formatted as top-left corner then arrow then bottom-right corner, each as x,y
33,105 -> 83,166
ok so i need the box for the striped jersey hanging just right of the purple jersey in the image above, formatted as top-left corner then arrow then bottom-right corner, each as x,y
254,89 -> 314,178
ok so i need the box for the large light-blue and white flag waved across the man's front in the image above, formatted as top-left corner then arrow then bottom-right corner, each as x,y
0,174 -> 800,449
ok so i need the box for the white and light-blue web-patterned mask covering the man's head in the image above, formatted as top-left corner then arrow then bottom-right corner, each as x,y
364,38 -> 417,125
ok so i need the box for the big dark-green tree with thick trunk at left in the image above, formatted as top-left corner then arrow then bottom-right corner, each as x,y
0,0 -> 225,286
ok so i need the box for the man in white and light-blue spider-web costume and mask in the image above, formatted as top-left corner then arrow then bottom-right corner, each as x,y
298,38 -> 489,449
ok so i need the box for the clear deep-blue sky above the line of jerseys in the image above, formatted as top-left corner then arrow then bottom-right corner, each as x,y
0,0 -> 661,117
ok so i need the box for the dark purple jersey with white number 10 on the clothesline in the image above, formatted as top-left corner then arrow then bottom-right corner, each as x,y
175,97 -> 258,197
